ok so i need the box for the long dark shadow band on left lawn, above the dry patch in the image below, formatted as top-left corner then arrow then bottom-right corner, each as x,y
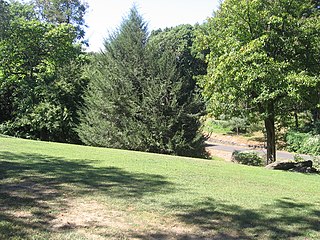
0,152 -> 172,198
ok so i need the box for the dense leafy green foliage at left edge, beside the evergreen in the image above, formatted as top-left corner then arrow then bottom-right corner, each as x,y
0,2 -> 86,142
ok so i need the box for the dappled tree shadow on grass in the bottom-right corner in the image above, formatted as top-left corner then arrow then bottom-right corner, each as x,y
165,198 -> 320,239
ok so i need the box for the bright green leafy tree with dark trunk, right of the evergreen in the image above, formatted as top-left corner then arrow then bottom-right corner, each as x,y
196,0 -> 320,162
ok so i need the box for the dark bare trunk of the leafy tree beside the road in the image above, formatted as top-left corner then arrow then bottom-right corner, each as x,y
264,105 -> 276,164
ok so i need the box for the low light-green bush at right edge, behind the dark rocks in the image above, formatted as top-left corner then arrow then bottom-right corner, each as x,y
285,131 -> 320,156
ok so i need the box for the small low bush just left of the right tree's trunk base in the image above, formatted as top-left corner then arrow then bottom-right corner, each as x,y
232,151 -> 264,166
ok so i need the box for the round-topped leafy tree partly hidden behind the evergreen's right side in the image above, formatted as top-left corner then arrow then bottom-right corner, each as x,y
149,25 -> 206,155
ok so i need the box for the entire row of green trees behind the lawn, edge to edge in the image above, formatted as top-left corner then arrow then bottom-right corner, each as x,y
0,0 -> 320,162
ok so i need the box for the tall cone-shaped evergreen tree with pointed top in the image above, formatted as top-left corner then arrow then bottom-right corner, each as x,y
78,8 -> 204,156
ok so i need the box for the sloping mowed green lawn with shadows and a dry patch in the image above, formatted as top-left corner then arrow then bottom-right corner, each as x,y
0,137 -> 320,239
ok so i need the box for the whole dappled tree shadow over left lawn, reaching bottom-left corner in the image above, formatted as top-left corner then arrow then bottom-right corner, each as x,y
0,152 -> 174,239
